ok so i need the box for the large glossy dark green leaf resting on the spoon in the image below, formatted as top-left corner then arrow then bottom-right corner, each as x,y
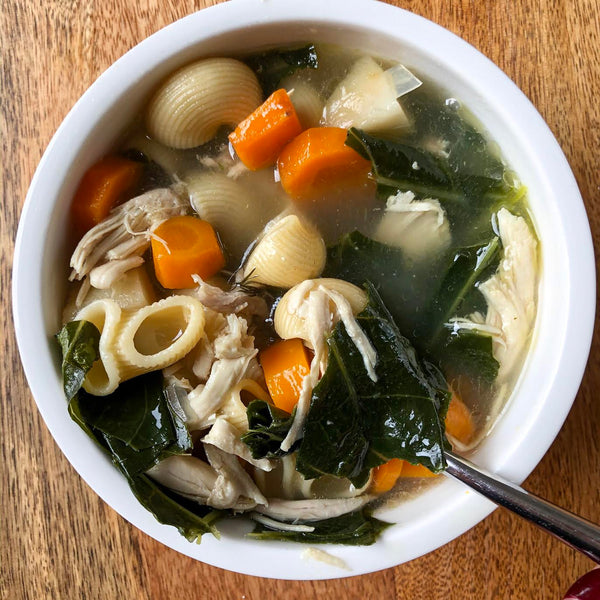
296,285 -> 449,485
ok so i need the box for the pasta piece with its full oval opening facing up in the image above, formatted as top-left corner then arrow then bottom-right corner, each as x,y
115,296 -> 204,381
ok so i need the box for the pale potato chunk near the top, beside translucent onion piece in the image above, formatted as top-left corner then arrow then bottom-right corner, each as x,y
324,56 -> 410,133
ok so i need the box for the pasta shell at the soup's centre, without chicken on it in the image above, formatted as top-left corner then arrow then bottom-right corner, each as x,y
244,215 -> 326,288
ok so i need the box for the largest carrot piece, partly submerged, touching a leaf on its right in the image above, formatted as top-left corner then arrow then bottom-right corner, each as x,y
277,127 -> 371,202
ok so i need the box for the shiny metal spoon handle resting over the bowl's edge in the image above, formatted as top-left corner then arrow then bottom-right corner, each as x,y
445,452 -> 600,563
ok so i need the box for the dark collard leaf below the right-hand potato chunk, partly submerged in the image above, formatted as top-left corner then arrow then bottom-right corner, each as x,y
324,231 -> 500,384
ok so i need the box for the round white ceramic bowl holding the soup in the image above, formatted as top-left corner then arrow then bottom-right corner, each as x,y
13,0 -> 595,579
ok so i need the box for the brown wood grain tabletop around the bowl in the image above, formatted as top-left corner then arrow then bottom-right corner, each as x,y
0,0 -> 600,600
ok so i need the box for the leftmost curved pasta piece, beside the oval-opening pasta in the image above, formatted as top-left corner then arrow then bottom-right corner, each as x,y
75,298 -> 122,396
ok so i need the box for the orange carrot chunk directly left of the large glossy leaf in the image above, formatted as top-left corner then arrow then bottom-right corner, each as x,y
258,338 -> 310,413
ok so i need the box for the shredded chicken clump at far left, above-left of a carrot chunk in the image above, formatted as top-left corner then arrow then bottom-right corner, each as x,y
70,186 -> 190,281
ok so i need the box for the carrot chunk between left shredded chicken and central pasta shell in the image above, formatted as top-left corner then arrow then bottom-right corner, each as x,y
152,215 -> 225,290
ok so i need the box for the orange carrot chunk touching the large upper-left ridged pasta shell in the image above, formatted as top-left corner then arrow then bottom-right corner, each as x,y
229,89 -> 302,171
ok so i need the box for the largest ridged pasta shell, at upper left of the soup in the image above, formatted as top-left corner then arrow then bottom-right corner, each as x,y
146,58 -> 262,148
